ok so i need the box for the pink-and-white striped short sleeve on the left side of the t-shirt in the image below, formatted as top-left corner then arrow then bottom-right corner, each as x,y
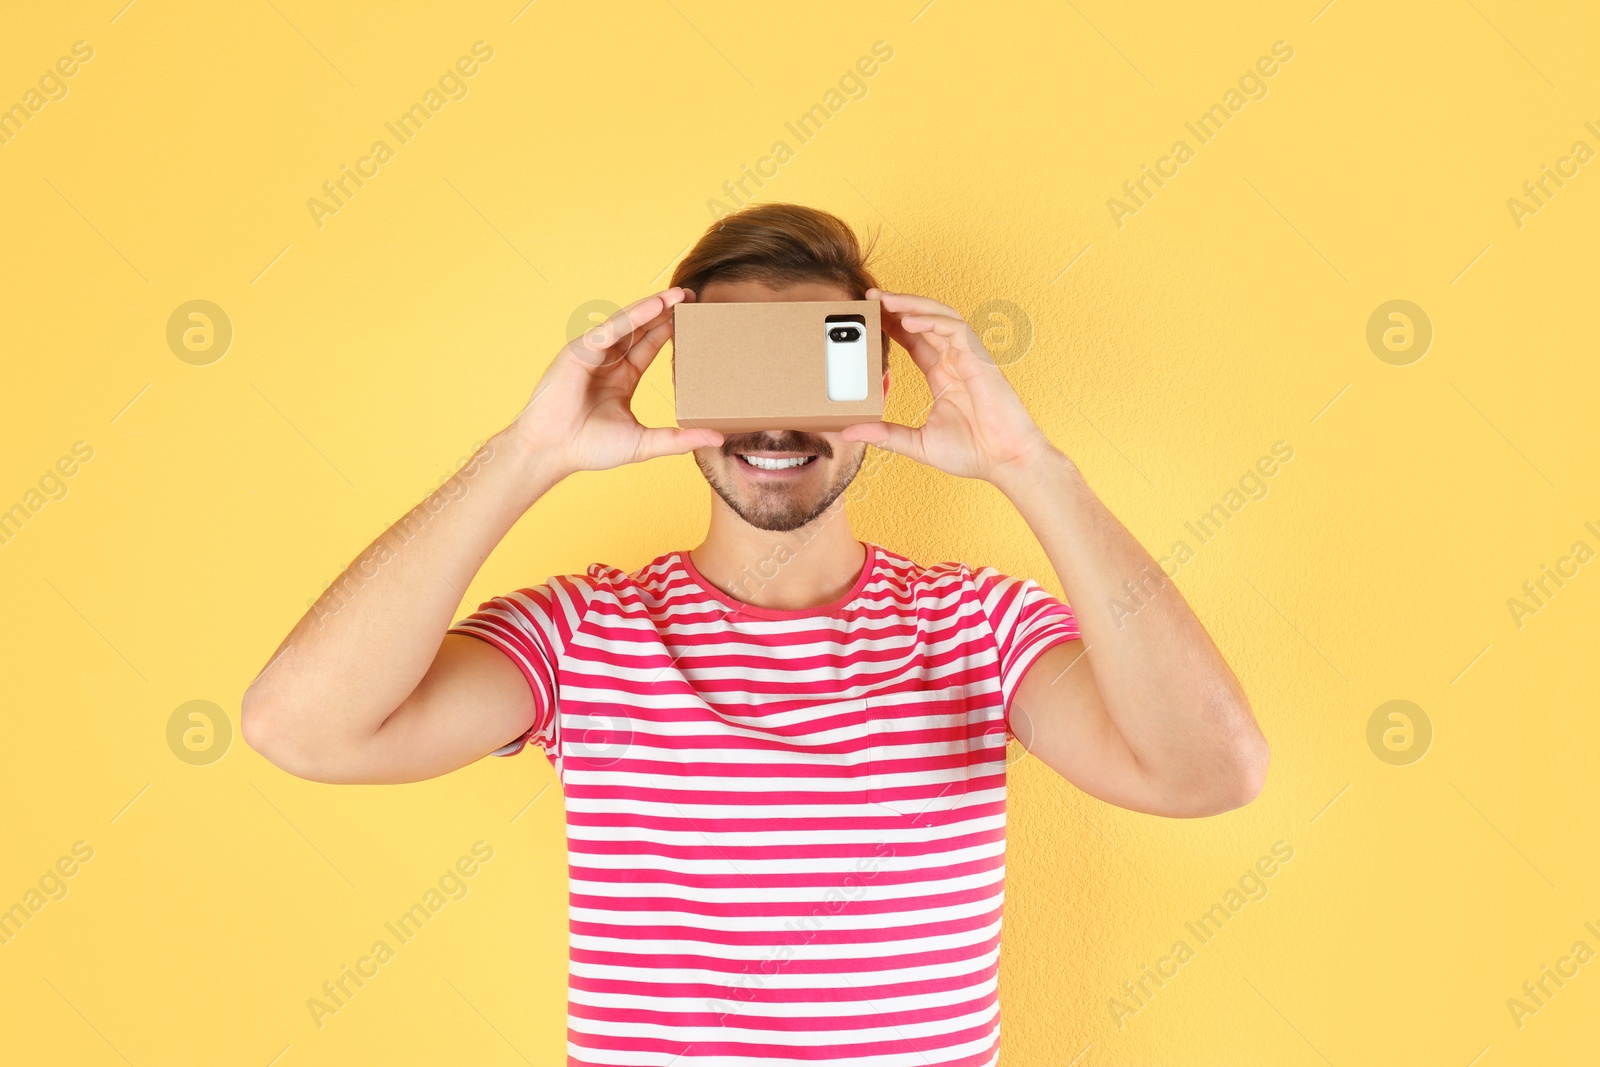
446,574 -> 594,761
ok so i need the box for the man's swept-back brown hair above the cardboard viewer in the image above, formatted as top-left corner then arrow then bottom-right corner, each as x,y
672,203 -> 878,301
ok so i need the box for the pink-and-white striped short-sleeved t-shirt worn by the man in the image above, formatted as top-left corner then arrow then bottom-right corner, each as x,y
451,544 -> 1078,1067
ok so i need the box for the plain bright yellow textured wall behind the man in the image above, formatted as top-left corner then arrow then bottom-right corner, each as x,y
0,0 -> 1600,1067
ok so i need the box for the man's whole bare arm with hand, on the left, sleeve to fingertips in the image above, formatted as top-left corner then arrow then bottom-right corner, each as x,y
242,288 -> 722,782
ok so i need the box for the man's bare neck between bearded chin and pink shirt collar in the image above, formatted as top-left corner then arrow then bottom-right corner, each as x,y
690,493 -> 867,611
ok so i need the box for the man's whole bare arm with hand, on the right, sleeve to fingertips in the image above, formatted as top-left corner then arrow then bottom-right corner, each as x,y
843,290 -> 1269,816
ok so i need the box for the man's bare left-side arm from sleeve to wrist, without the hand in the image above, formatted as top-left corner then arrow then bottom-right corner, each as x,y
243,429 -> 558,782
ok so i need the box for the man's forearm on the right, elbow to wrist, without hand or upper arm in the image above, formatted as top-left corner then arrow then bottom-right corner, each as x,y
995,448 -> 1266,793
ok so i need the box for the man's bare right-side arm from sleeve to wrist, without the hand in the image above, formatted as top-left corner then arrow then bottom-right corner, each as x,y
997,450 -> 1269,817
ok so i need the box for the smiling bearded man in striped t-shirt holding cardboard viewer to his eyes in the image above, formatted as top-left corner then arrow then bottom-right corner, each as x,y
243,205 -> 1267,1067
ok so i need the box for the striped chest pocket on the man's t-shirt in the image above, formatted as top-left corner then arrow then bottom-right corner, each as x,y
866,691 -> 1005,816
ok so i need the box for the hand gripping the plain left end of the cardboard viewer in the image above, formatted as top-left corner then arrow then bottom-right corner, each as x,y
512,288 -> 723,475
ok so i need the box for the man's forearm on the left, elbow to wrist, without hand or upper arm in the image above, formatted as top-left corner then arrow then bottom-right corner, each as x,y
236,426 -> 562,741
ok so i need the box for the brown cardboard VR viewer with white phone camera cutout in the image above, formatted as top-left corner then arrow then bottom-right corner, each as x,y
672,301 -> 885,434
